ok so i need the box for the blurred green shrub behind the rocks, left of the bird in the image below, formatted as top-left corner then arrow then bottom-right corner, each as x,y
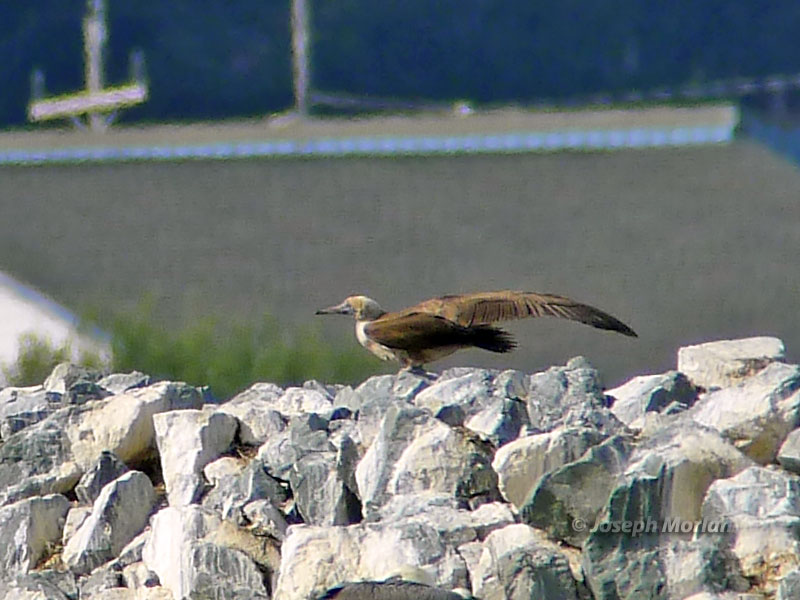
105,303 -> 380,399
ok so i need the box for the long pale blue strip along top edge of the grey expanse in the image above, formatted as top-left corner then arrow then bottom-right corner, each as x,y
0,125 -> 734,165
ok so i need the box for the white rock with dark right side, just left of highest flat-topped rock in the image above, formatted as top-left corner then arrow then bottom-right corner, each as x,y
606,371 -> 698,429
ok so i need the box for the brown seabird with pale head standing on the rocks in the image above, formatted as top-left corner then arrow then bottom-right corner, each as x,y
317,290 -> 637,369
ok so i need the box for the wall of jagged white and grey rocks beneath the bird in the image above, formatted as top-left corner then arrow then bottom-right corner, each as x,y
0,338 -> 800,600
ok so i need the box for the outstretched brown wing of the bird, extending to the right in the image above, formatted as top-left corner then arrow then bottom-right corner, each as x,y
402,290 -> 637,337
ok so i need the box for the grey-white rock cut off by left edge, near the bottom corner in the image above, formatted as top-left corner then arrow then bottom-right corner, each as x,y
0,494 -> 69,580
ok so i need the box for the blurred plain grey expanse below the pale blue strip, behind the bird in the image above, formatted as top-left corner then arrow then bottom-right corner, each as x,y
0,129 -> 800,384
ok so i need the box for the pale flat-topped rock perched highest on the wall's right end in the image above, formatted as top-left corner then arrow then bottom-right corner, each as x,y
678,337 -> 785,390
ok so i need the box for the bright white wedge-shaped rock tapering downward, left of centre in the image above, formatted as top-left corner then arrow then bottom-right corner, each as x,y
153,410 -> 237,506
